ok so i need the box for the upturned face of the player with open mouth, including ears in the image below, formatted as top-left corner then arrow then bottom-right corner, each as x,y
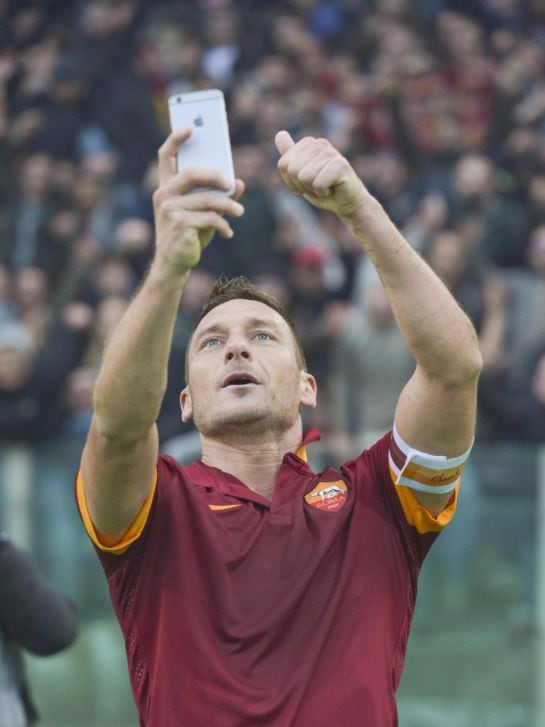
180,300 -> 316,436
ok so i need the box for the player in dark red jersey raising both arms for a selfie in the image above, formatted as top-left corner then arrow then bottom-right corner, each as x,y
77,129 -> 481,727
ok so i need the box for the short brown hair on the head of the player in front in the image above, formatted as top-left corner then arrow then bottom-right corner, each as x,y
185,275 -> 307,383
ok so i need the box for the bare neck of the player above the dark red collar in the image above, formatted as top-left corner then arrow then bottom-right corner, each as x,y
201,420 -> 303,499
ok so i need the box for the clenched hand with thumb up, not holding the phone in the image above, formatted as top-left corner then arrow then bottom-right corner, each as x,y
275,131 -> 368,221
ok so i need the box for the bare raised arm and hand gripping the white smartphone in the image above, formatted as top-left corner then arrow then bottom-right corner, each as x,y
81,128 -> 244,545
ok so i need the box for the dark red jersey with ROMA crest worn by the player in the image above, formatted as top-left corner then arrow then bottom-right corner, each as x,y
78,434 -> 446,727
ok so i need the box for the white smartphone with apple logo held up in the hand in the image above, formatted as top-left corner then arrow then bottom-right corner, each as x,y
168,88 -> 235,195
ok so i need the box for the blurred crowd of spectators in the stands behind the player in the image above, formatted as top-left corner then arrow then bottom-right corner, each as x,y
0,0 -> 545,459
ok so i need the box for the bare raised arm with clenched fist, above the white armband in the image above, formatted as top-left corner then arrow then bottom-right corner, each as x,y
275,131 -> 482,514
